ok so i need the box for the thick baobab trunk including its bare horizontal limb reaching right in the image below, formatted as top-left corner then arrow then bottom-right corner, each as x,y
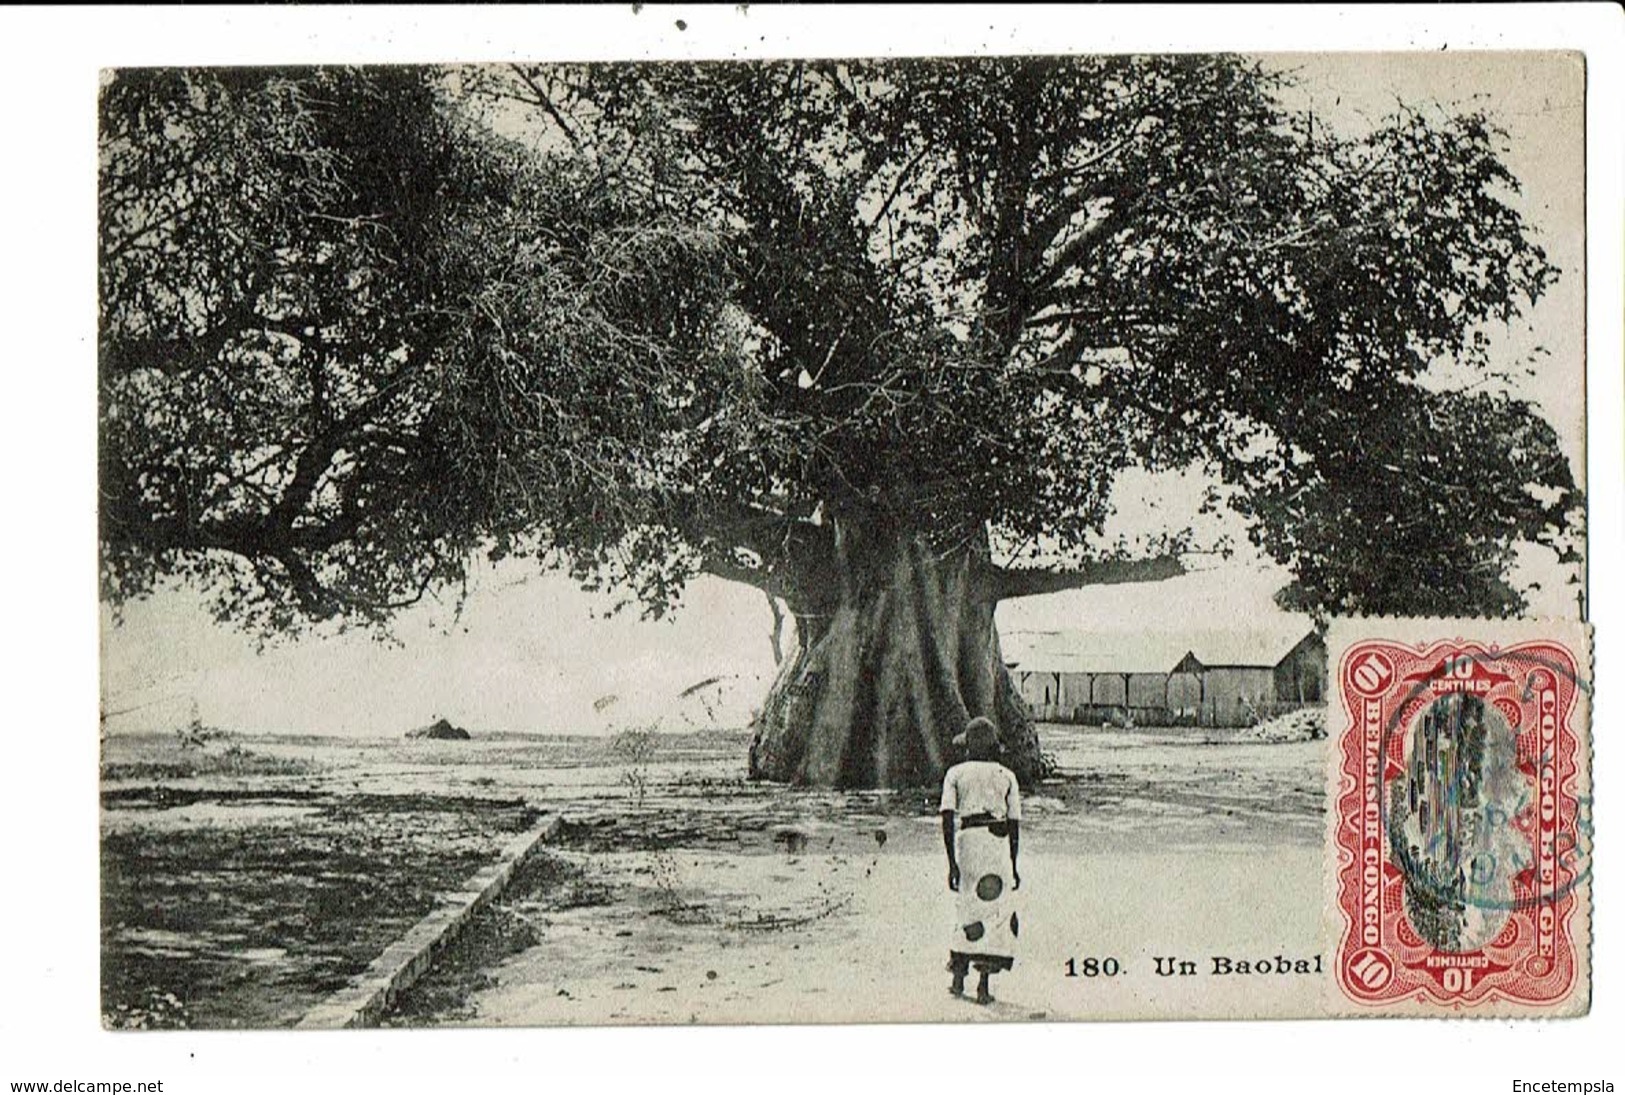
705,510 -> 1185,788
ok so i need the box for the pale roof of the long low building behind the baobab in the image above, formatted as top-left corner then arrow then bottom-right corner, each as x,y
1001,617 -> 1313,673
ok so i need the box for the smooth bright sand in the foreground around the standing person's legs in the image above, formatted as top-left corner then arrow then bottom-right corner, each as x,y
460,838 -> 1323,1025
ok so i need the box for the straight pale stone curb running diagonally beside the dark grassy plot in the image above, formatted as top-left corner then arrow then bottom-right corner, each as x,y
294,814 -> 564,1030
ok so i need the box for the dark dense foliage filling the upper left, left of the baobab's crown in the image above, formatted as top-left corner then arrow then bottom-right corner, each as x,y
99,70 -> 720,630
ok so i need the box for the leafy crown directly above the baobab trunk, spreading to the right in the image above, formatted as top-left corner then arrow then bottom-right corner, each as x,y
474,57 -> 1581,614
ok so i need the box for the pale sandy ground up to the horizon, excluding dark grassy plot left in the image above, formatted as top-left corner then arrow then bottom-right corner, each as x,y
104,728 -> 1328,1025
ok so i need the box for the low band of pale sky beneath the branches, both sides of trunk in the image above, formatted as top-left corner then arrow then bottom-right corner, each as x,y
102,545 -> 1306,736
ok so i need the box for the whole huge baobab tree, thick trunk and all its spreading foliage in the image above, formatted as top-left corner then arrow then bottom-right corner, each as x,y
102,57 -> 1580,786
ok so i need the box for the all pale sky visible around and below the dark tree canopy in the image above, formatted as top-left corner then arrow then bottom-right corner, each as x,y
102,52 -> 1584,736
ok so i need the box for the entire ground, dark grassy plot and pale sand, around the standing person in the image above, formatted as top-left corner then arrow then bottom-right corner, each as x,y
102,726 -> 1326,1027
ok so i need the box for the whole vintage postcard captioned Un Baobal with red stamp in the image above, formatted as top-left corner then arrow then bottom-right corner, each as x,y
98,50 -> 1593,1030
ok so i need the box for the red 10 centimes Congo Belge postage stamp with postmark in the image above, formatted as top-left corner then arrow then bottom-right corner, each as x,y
1331,621 -> 1591,1014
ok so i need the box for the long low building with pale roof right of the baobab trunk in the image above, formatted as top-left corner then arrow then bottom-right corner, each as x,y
1006,622 -> 1326,726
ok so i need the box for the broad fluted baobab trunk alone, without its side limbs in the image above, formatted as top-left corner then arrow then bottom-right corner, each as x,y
751,526 -> 1045,788
